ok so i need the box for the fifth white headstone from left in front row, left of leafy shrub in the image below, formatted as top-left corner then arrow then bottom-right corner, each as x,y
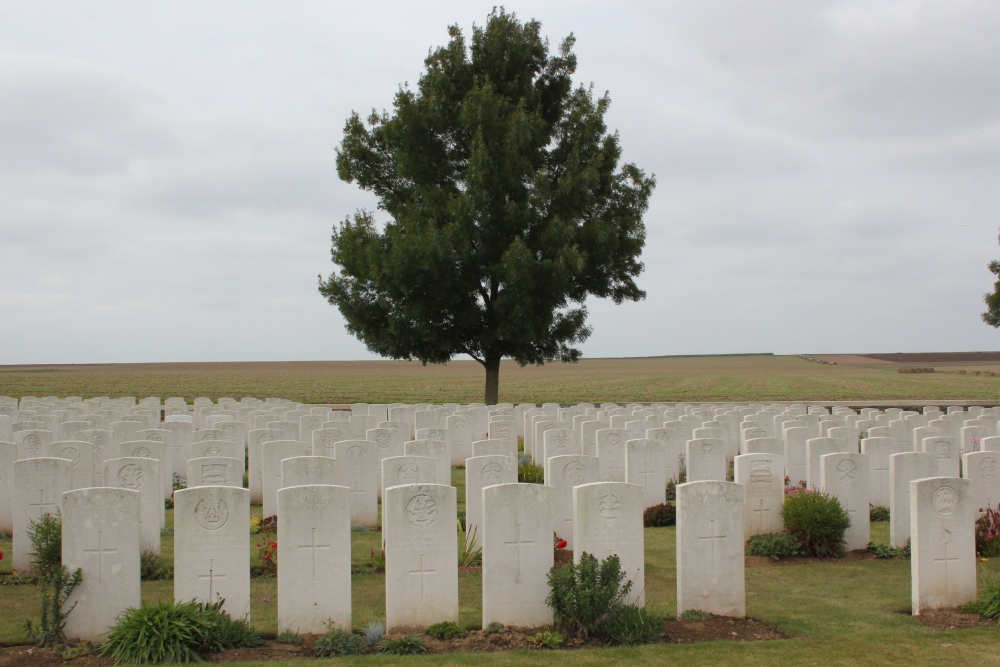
478,482 -> 553,628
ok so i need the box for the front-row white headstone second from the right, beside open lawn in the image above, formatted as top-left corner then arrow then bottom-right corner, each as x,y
677,481 -> 746,618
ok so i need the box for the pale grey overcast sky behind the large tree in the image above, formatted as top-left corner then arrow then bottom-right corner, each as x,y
0,0 -> 1000,364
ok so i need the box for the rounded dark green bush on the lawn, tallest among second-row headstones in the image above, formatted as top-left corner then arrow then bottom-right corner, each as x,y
781,491 -> 851,558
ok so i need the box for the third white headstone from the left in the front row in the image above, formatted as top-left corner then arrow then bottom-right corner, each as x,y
278,482 -> 351,634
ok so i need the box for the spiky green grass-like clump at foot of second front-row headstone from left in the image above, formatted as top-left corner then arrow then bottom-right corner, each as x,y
100,600 -> 263,665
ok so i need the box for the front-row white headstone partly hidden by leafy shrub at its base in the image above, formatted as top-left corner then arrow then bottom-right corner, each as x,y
573,482 -> 646,607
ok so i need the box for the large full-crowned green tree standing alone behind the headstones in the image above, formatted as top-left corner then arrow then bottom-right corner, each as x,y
319,9 -> 655,404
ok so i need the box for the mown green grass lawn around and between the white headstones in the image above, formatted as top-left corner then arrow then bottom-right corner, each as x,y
0,469 -> 1000,667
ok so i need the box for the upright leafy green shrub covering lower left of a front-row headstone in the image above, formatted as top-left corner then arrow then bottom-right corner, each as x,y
545,553 -> 632,638
